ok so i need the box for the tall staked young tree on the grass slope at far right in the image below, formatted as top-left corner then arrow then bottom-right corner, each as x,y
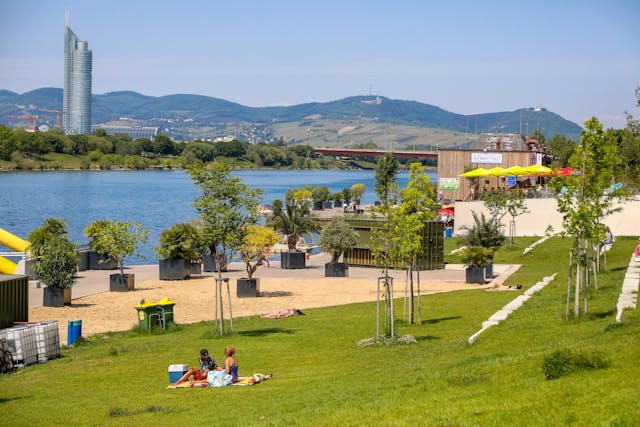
551,117 -> 624,318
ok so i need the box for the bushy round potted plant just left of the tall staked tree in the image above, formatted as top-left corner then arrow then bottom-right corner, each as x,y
154,222 -> 202,280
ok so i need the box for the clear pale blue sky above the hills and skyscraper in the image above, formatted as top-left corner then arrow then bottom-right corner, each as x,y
0,0 -> 640,128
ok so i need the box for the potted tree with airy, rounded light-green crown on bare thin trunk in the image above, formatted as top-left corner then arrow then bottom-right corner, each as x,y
93,220 -> 149,292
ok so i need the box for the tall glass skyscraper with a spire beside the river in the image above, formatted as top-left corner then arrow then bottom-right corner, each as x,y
62,11 -> 92,134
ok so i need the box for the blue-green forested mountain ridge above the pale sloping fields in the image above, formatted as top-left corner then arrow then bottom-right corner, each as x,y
0,87 -> 582,140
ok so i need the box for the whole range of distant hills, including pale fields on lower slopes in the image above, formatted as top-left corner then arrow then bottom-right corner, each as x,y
0,88 -> 581,146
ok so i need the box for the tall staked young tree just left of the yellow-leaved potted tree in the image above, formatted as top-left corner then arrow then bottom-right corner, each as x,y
190,162 -> 261,335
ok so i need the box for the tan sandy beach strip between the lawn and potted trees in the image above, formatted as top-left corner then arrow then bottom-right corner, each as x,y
29,254 -> 517,344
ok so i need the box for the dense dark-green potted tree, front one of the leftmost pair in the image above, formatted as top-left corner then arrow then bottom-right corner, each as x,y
29,218 -> 78,307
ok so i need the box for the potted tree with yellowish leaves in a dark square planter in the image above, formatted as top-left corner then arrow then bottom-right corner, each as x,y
236,225 -> 280,297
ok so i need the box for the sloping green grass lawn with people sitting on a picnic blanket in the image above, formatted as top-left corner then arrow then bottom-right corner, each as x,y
0,237 -> 640,426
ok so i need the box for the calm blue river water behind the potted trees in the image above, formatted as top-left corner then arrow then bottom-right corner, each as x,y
0,170 -> 436,265
